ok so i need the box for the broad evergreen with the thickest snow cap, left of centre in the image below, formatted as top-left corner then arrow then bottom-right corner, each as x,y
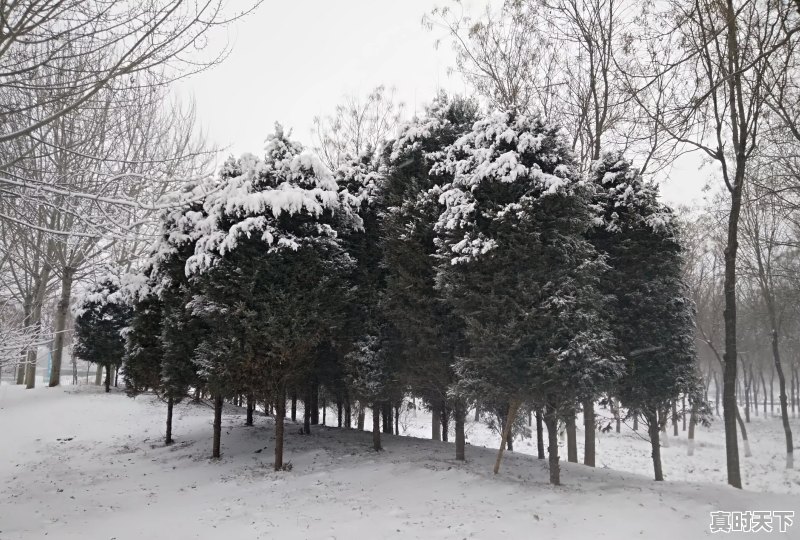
186,126 -> 359,470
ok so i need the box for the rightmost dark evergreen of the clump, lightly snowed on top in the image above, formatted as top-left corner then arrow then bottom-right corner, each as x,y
589,153 -> 705,480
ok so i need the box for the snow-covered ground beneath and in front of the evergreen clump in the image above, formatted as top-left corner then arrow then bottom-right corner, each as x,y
0,385 -> 800,540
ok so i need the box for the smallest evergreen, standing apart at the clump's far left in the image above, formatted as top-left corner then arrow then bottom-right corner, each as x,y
73,277 -> 131,392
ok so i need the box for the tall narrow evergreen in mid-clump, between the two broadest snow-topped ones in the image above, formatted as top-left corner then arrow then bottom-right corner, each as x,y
380,93 -> 478,460
